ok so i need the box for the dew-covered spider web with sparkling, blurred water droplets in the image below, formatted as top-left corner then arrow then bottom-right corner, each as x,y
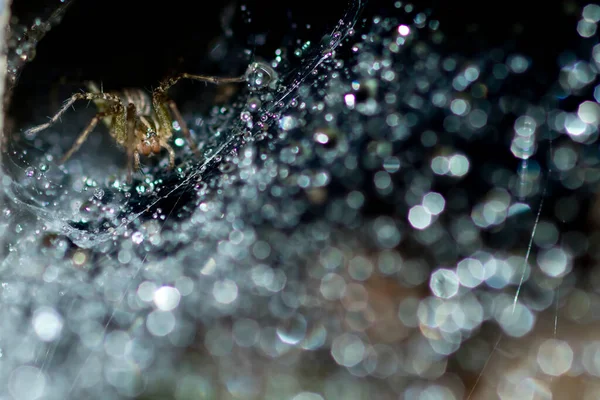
0,1 -> 600,400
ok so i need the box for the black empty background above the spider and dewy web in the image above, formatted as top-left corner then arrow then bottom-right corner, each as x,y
9,0 -> 581,119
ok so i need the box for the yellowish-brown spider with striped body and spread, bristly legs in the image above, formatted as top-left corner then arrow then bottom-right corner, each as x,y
25,72 -> 248,181
